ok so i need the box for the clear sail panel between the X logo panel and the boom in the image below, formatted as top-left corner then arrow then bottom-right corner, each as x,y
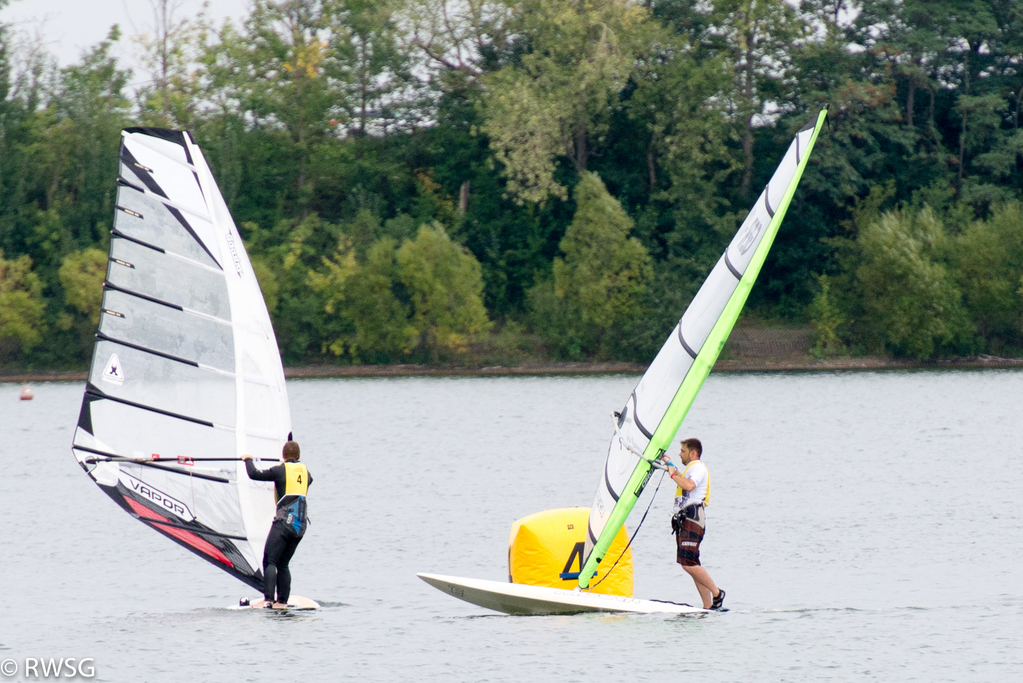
85,400 -> 236,464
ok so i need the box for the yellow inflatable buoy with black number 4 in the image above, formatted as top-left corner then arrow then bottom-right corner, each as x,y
508,507 -> 632,597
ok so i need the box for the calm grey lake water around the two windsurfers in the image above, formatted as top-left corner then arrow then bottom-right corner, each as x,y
0,371 -> 1023,683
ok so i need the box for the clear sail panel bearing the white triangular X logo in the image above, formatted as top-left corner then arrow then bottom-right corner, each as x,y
89,340 -> 235,426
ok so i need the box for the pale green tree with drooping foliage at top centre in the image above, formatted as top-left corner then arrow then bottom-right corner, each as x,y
483,0 -> 649,203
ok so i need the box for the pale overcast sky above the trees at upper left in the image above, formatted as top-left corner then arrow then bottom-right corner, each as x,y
0,0 -> 250,82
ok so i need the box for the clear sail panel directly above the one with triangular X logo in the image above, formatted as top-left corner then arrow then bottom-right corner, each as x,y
99,289 -> 234,372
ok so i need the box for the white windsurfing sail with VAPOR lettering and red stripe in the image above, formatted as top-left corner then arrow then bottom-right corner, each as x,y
73,128 -> 292,589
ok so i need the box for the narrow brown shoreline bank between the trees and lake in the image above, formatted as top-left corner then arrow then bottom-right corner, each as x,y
0,356 -> 1023,383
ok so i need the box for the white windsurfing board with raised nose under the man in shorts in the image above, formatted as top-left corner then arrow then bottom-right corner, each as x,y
416,574 -> 707,614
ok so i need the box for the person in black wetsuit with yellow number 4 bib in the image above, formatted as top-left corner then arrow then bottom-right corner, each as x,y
241,441 -> 313,608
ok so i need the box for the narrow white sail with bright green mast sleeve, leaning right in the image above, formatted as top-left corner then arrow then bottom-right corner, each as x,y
579,109 -> 827,588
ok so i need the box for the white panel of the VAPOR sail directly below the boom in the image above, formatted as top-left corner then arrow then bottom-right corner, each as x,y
120,461 -> 246,537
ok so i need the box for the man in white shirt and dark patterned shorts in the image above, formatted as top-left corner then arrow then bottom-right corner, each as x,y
668,439 -> 724,609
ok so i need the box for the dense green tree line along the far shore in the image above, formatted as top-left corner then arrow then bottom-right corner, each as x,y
0,0 -> 1023,368
